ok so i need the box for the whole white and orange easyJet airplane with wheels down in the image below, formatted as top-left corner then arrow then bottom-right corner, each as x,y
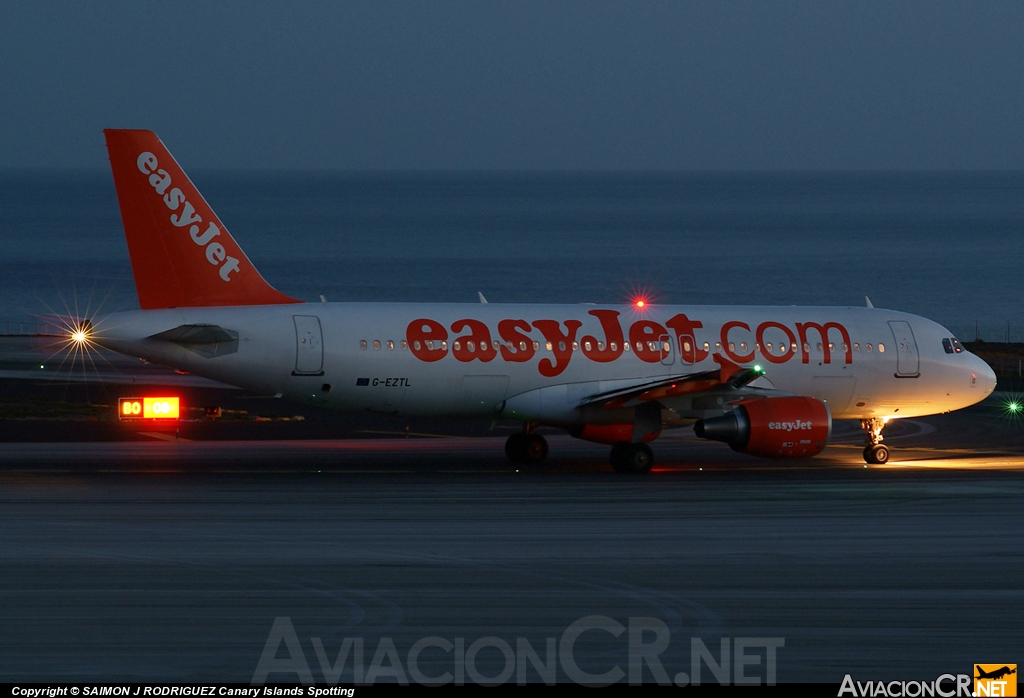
86,130 -> 995,472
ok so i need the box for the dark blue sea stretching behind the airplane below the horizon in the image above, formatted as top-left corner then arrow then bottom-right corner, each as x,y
0,170 -> 1024,341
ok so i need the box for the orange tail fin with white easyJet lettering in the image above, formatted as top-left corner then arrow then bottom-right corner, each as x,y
103,129 -> 302,309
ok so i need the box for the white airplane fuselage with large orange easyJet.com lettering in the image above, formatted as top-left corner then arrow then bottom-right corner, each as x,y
94,303 -> 995,425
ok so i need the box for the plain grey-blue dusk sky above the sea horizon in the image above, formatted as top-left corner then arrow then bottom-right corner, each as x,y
0,0 -> 1024,170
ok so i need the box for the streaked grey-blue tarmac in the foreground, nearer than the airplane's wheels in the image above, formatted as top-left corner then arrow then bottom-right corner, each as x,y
0,458 -> 1024,683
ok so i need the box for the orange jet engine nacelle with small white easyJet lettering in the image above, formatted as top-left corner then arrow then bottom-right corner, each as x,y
693,397 -> 831,459
